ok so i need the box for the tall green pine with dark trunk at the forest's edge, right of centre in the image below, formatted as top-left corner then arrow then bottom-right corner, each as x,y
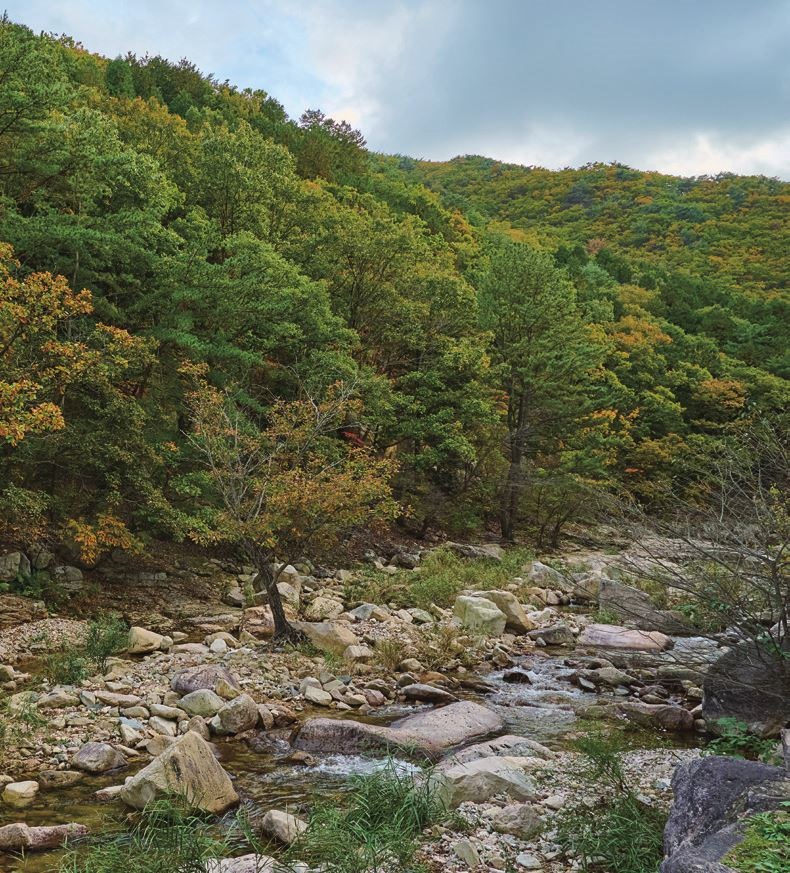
478,240 -> 603,540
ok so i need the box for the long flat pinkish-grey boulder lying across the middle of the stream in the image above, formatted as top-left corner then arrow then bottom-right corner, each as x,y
293,700 -> 503,759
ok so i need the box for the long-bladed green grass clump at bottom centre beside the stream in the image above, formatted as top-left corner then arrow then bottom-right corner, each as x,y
288,761 -> 447,873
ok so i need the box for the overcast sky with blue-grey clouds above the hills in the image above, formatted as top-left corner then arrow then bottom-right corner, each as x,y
7,0 -> 790,179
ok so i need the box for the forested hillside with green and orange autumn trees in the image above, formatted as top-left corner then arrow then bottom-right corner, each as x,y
0,20 -> 790,561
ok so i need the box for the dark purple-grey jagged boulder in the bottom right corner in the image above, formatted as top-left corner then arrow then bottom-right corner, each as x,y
661,757 -> 790,873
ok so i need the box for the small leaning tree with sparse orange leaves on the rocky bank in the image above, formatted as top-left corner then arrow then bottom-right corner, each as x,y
184,366 -> 397,639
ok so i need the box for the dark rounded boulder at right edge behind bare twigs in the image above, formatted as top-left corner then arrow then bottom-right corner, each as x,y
702,639 -> 790,737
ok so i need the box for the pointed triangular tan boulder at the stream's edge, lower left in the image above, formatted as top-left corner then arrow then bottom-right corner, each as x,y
119,731 -> 239,814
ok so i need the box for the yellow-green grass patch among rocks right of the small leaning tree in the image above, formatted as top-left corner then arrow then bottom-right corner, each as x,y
345,549 -> 533,609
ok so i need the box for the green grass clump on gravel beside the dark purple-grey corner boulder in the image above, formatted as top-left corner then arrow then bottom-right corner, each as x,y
558,734 -> 666,873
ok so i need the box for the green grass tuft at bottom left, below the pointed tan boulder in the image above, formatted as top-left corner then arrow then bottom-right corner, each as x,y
59,800 -> 230,873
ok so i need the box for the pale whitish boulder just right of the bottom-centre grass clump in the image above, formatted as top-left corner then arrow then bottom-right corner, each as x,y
431,757 -> 536,808
